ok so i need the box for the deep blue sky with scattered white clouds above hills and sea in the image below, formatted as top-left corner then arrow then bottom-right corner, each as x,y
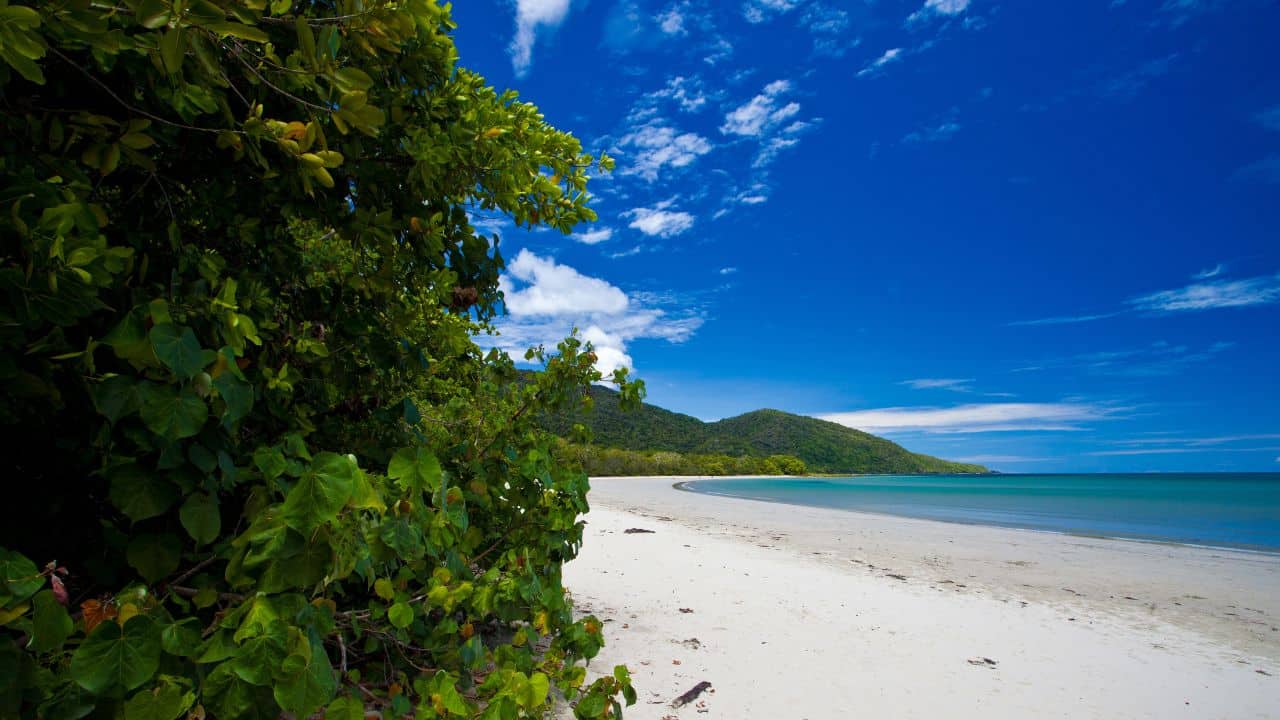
454,0 -> 1280,473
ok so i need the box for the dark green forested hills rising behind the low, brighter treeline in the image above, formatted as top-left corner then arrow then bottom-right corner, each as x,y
543,386 -> 987,473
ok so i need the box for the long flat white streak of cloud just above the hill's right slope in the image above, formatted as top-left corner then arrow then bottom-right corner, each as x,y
817,402 -> 1116,433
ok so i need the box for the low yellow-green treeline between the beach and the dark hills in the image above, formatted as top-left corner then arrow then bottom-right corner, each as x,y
558,442 -> 808,475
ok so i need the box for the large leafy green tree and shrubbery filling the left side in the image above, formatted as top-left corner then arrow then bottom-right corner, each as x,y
0,0 -> 643,720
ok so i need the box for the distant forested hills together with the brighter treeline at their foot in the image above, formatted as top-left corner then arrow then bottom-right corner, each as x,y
540,386 -> 987,475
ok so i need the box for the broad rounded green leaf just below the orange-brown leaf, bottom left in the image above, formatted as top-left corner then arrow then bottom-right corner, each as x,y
70,615 -> 160,694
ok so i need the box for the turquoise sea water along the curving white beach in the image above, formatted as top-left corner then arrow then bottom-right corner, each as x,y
682,473 -> 1280,552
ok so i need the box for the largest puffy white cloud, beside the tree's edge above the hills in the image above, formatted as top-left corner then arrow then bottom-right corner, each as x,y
490,250 -> 703,374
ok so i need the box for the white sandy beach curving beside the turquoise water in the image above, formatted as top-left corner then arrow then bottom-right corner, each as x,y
564,478 -> 1280,720
